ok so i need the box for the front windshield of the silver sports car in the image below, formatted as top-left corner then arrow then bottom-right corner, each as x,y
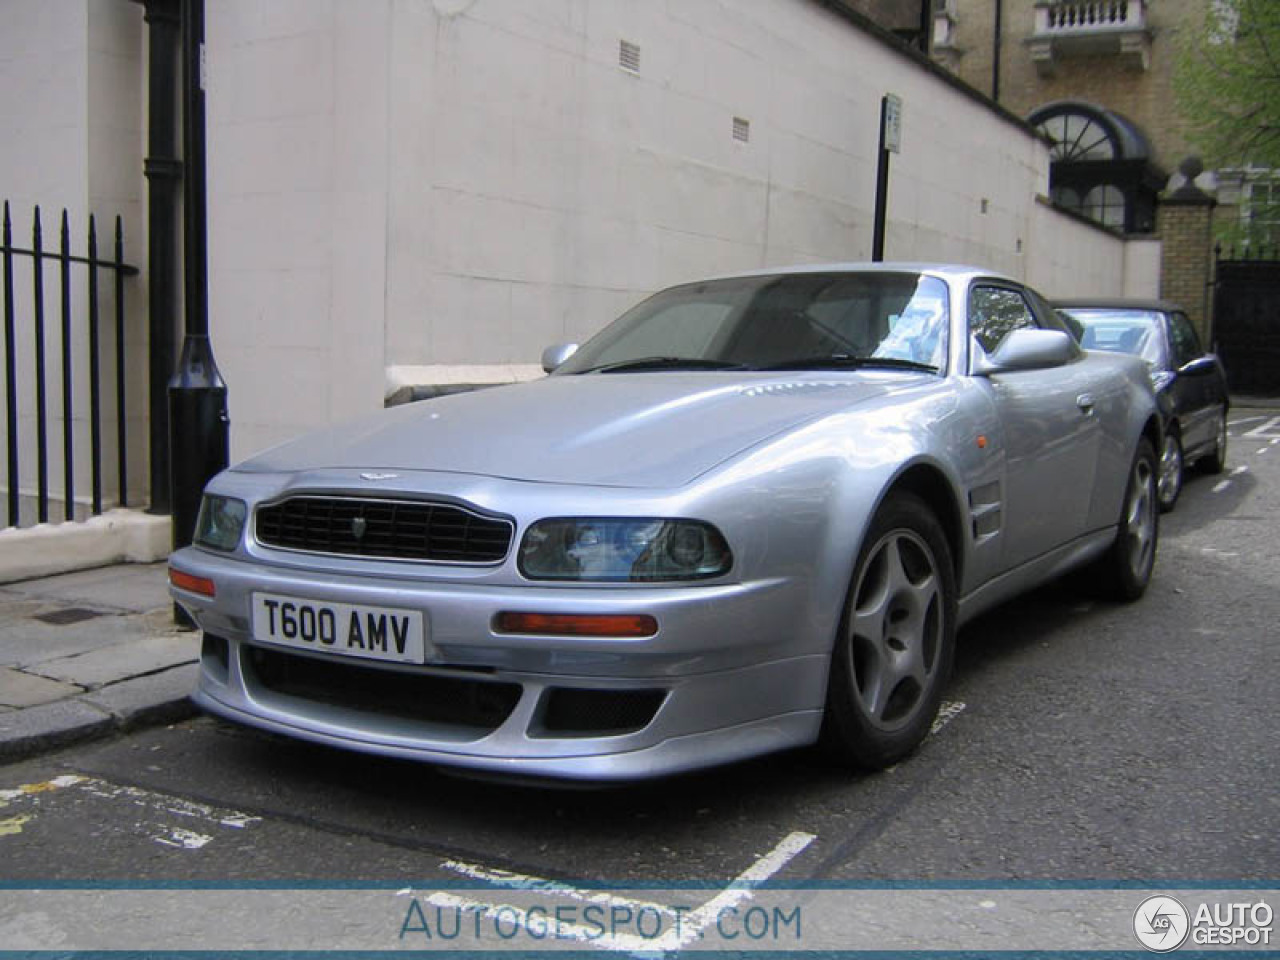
556,271 -> 947,374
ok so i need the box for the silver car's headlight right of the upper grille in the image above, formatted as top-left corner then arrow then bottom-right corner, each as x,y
520,517 -> 733,582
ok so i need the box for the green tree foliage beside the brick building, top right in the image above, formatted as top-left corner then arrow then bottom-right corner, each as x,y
1175,0 -> 1280,168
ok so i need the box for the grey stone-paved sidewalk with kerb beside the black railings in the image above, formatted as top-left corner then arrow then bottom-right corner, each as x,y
0,563 -> 200,763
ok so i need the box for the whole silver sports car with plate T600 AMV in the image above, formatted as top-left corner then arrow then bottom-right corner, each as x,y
170,264 -> 1162,780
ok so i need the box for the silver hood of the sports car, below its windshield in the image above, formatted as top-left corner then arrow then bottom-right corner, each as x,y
237,371 -> 911,488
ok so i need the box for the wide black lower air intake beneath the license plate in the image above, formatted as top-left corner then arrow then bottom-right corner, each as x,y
241,646 -> 521,732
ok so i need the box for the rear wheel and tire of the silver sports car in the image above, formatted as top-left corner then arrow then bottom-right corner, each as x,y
1093,436 -> 1160,602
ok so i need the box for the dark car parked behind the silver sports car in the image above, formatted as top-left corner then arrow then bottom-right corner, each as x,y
1053,300 -> 1231,511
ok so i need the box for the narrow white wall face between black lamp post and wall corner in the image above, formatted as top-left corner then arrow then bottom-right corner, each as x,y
206,0 -> 392,458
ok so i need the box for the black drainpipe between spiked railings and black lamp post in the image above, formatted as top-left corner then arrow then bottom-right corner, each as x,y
138,0 -> 182,513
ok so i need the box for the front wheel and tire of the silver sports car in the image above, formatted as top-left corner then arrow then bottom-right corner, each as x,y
822,494 -> 956,771
